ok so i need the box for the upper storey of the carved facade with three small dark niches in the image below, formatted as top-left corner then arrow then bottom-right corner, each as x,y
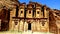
12,2 -> 50,18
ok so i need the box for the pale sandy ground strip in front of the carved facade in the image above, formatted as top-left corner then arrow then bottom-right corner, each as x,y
0,31 -> 52,34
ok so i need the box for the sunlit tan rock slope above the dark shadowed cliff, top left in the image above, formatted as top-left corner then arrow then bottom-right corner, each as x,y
0,0 -> 19,8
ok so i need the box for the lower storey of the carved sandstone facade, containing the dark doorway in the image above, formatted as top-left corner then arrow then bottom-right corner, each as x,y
10,19 -> 49,32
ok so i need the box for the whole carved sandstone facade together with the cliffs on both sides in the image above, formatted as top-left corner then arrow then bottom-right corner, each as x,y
0,0 -> 60,34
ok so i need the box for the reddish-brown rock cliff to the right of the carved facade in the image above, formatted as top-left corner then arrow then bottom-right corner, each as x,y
49,10 -> 60,34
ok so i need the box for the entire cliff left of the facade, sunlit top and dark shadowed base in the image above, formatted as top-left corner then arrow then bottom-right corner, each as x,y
0,0 -> 19,31
